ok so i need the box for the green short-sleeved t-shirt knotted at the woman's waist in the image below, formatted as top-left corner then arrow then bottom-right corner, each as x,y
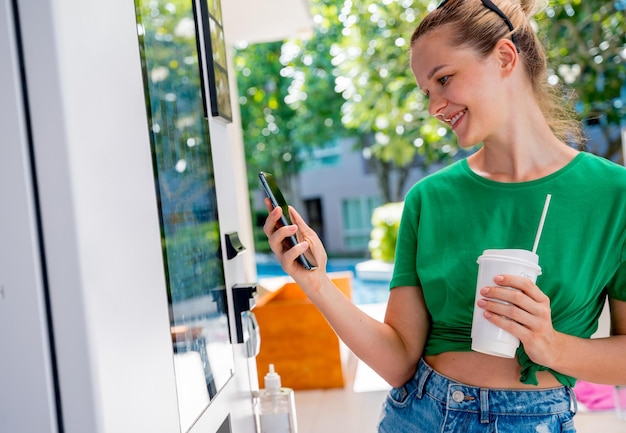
390,153 -> 626,386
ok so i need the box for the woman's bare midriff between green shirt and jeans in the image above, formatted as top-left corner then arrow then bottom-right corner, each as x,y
424,352 -> 561,389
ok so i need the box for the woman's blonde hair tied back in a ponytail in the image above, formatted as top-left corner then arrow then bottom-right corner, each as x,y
411,0 -> 585,148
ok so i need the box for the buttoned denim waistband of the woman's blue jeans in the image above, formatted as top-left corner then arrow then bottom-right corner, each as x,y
407,359 -> 577,422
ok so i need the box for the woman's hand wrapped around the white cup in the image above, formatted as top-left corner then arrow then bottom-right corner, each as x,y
478,275 -> 559,366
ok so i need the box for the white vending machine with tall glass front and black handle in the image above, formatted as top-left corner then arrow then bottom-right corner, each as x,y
0,0 -> 304,433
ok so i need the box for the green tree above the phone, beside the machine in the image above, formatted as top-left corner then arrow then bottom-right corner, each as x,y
235,0 -> 346,199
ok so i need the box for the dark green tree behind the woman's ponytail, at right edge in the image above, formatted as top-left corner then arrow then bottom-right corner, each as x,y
537,0 -> 626,163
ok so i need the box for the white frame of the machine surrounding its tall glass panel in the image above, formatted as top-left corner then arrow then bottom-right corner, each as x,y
0,0 -> 257,433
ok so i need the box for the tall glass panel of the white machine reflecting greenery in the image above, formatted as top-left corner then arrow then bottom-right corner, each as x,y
135,0 -> 234,431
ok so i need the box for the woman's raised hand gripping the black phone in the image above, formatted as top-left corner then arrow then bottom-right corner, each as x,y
263,199 -> 328,292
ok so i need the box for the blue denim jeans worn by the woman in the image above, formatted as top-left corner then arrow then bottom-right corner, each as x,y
378,360 -> 576,433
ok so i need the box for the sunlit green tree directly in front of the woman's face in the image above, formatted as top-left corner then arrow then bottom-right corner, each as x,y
332,0 -> 459,202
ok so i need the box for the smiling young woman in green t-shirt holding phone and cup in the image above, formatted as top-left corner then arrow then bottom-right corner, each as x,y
264,0 -> 626,433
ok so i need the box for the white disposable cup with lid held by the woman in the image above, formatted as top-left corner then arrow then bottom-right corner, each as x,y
472,249 -> 541,358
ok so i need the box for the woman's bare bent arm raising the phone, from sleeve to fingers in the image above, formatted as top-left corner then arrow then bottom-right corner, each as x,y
264,204 -> 429,386
